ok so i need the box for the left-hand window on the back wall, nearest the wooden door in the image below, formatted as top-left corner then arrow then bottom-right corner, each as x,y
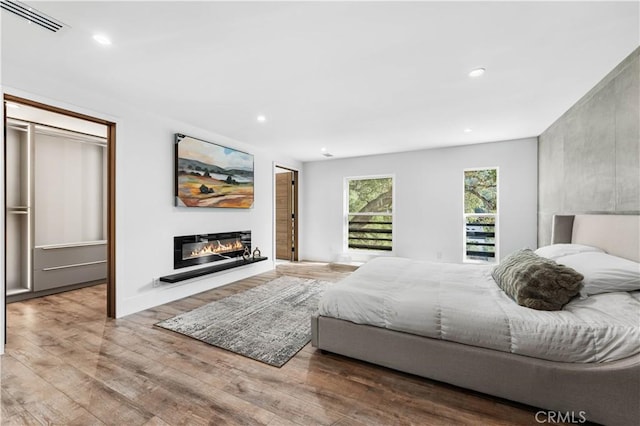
345,176 -> 393,251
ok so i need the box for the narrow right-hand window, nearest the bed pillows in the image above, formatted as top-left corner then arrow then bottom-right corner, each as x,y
463,168 -> 498,263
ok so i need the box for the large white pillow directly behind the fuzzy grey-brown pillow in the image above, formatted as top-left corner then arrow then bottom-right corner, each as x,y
556,252 -> 640,295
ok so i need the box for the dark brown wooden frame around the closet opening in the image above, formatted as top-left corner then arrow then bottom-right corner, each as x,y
3,94 -> 116,318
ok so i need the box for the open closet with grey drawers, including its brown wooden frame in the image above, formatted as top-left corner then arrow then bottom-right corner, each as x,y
4,95 -> 115,322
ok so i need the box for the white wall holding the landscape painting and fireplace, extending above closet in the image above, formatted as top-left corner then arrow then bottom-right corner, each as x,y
0,83 -> 302,317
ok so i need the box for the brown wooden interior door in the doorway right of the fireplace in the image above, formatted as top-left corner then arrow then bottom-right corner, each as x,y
276,172 -> 295,260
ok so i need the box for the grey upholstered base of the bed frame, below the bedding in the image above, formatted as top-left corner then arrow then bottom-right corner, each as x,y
311,316 -> 640,425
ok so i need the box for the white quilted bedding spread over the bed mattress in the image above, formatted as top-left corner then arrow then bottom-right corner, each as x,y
319,257 -> 640,363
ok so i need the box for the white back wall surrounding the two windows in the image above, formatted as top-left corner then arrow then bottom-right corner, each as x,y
300,138 -> 537,262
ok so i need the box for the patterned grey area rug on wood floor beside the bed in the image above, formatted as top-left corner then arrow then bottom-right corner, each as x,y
156,276 -> 331,367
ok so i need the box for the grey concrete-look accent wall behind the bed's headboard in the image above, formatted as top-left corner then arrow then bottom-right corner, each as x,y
538,48 -> 640,246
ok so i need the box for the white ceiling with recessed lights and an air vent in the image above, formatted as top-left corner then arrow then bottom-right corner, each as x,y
1,1 -> 640,161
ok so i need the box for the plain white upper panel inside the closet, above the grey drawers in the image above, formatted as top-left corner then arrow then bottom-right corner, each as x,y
34,134 -> 105,246
